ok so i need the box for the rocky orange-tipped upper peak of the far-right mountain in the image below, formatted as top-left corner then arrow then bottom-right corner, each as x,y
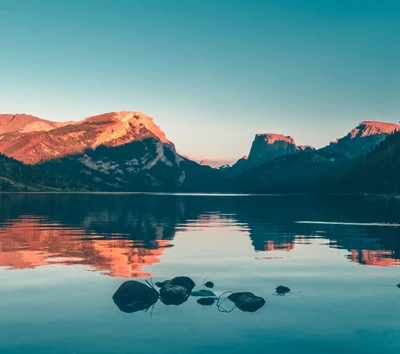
323,121 -> 400,159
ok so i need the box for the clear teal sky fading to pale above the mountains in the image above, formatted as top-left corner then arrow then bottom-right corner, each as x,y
0,0 -> 400,159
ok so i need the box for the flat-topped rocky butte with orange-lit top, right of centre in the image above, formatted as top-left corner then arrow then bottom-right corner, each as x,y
248,134 -> 296,166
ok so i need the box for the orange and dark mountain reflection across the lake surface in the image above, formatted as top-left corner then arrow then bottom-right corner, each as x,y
0,194 -> 400,278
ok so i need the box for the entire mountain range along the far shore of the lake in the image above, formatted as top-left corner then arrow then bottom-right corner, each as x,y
0,111 -> 400,193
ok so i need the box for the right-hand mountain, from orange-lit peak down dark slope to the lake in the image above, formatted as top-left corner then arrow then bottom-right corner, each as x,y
231,121 -> 400,193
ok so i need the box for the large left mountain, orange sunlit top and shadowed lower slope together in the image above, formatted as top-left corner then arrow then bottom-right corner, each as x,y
0,111 -> 220,191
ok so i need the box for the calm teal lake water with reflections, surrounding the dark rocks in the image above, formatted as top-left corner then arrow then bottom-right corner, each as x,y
0,194 -> 400,354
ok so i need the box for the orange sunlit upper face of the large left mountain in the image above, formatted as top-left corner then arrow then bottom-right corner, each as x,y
0,111 -> 173,164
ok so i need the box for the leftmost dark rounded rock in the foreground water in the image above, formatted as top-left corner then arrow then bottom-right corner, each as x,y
113,280 -> 159,313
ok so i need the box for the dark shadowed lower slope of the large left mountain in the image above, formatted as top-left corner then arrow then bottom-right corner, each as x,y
38,138 -> 220,191
